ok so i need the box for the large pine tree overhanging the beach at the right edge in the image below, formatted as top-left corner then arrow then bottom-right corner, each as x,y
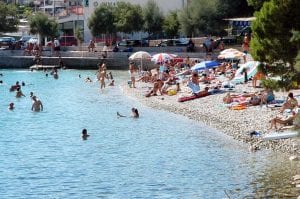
250,0 -> 300,89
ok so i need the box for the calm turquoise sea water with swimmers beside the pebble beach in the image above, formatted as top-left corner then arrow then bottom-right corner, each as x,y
0,70 -> 299,199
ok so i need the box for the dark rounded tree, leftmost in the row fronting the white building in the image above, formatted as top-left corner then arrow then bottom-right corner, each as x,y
88,4 -> 116,36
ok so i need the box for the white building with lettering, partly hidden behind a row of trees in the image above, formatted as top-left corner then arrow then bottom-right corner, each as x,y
83,0 -> 189,42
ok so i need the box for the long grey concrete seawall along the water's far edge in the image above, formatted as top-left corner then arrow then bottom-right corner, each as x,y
0,47 -> 209,70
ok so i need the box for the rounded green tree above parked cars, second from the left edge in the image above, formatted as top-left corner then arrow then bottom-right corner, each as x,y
29,12 -> 58,39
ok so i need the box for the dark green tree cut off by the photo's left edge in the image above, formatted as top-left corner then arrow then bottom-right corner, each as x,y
0,1 -> 19,32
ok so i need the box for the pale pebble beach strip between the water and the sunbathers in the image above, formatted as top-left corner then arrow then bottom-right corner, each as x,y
121,82 -> 300,157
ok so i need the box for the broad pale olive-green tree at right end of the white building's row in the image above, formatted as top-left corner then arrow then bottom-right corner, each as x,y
178,0 -> 218,37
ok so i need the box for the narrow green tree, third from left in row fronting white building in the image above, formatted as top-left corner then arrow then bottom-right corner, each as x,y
143,0 -> 163,34
